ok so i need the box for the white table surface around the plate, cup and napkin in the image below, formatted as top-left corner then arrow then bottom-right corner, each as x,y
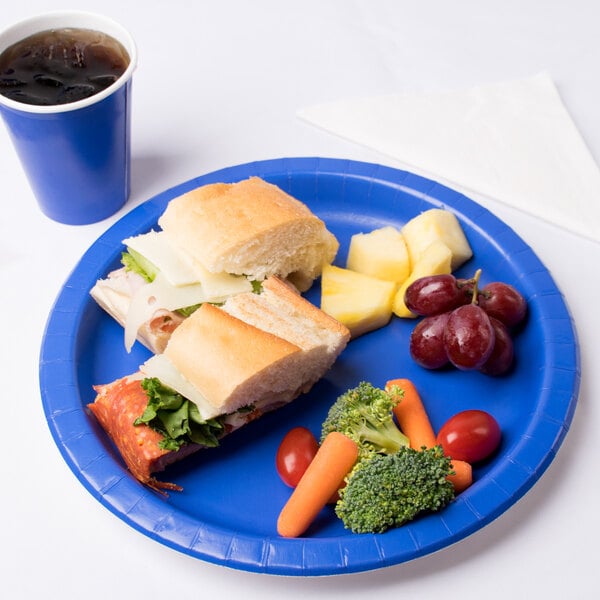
0,0 -> 600,600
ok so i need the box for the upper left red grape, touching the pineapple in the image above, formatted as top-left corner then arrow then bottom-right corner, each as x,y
404,274 -> 472,316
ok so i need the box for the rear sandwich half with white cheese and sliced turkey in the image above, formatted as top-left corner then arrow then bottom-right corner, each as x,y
90,177 -> 339,354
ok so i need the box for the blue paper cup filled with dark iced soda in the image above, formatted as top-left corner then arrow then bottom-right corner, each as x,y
0,12 -> 136,224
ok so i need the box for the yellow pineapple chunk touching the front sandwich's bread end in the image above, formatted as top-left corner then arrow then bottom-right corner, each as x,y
321,265 -> 398,338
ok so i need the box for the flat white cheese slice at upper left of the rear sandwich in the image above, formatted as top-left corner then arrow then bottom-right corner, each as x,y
123,231 -> 201,285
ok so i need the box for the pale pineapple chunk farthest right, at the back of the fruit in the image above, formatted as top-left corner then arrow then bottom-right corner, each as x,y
401,208 -> 473,271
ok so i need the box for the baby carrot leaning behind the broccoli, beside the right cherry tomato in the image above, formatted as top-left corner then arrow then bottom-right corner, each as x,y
385,379 -> 436,450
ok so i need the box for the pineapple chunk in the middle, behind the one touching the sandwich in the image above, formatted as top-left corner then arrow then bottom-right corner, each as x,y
346,226 -> 410,283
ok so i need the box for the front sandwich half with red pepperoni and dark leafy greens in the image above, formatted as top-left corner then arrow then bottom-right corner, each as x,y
88,276 -> 350,492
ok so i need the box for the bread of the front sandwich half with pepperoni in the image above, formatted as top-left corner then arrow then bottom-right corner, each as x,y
159,277 -> 349,414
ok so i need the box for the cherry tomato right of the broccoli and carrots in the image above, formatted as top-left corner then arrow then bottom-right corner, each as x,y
437,410 -> 502,463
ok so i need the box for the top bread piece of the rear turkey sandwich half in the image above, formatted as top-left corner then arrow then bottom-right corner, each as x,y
158,177 -> 339,291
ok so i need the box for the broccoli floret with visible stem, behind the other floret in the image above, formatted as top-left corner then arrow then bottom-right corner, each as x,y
321,381 -> 409,462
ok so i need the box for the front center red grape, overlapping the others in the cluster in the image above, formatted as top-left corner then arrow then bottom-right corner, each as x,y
444,304 -> 495,371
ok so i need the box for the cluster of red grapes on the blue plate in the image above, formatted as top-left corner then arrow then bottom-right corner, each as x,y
404,270 -> 527,375
